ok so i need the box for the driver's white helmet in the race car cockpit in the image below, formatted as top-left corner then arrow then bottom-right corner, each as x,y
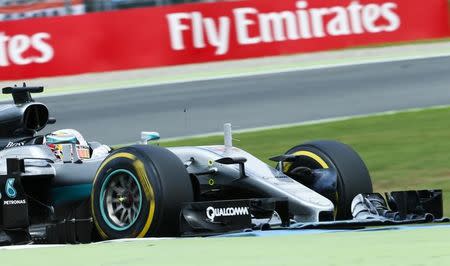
44,129 -> 90,159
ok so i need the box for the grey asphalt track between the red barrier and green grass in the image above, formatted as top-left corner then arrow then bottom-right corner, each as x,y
36,54 -> 450,144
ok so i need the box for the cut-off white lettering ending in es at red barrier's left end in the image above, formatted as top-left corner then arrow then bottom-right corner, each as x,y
0,32 -> 54,68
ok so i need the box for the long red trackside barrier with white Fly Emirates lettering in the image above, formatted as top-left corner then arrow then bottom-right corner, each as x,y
0,0 -> 450,80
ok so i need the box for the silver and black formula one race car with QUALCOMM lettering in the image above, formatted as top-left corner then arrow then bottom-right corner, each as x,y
0,85 -> 442,245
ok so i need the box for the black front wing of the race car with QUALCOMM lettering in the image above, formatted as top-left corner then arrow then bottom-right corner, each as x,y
180,190 -> 450,236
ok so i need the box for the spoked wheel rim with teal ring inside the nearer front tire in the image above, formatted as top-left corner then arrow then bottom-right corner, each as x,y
100,169 -> 142,231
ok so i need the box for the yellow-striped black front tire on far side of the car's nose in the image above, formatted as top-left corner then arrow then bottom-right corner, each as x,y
283,140 -> 373,220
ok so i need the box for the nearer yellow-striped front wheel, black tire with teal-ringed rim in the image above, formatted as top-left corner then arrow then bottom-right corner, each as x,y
91,145 -> 194,240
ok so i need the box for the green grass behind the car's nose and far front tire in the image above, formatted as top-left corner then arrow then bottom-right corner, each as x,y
161,108 -> 450,215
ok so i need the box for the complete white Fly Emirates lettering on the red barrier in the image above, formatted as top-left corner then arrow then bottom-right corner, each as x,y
167,1 -> 401,55
